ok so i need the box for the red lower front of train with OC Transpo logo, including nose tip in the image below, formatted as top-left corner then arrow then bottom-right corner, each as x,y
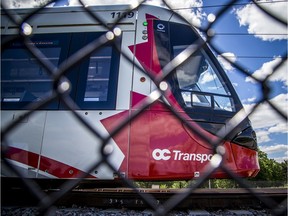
129,102 -> 259,180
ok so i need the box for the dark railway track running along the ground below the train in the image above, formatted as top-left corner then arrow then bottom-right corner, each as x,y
2,188 -> 287,215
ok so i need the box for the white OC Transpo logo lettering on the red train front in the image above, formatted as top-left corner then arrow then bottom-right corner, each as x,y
152,149 -> 213,163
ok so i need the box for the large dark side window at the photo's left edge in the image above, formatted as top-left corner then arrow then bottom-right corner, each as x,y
1,35 -> 68,109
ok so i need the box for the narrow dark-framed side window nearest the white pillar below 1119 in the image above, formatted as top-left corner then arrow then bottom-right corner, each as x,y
76,33 -> 120,109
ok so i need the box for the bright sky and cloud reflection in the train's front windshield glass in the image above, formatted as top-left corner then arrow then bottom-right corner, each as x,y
173,46 -> 235,112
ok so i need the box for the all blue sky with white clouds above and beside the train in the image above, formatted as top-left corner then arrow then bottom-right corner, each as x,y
5,0 -> 288,162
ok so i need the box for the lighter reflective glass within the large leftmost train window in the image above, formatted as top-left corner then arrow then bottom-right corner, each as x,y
1,47 -> 61,103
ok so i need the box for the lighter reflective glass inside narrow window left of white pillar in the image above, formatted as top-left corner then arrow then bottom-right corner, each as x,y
84,47 -> 112,101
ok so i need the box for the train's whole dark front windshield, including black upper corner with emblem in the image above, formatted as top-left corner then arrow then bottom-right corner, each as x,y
154,20 -> 239,115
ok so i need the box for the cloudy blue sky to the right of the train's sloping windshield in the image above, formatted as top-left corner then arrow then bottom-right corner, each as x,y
203,0 -> 288,161
